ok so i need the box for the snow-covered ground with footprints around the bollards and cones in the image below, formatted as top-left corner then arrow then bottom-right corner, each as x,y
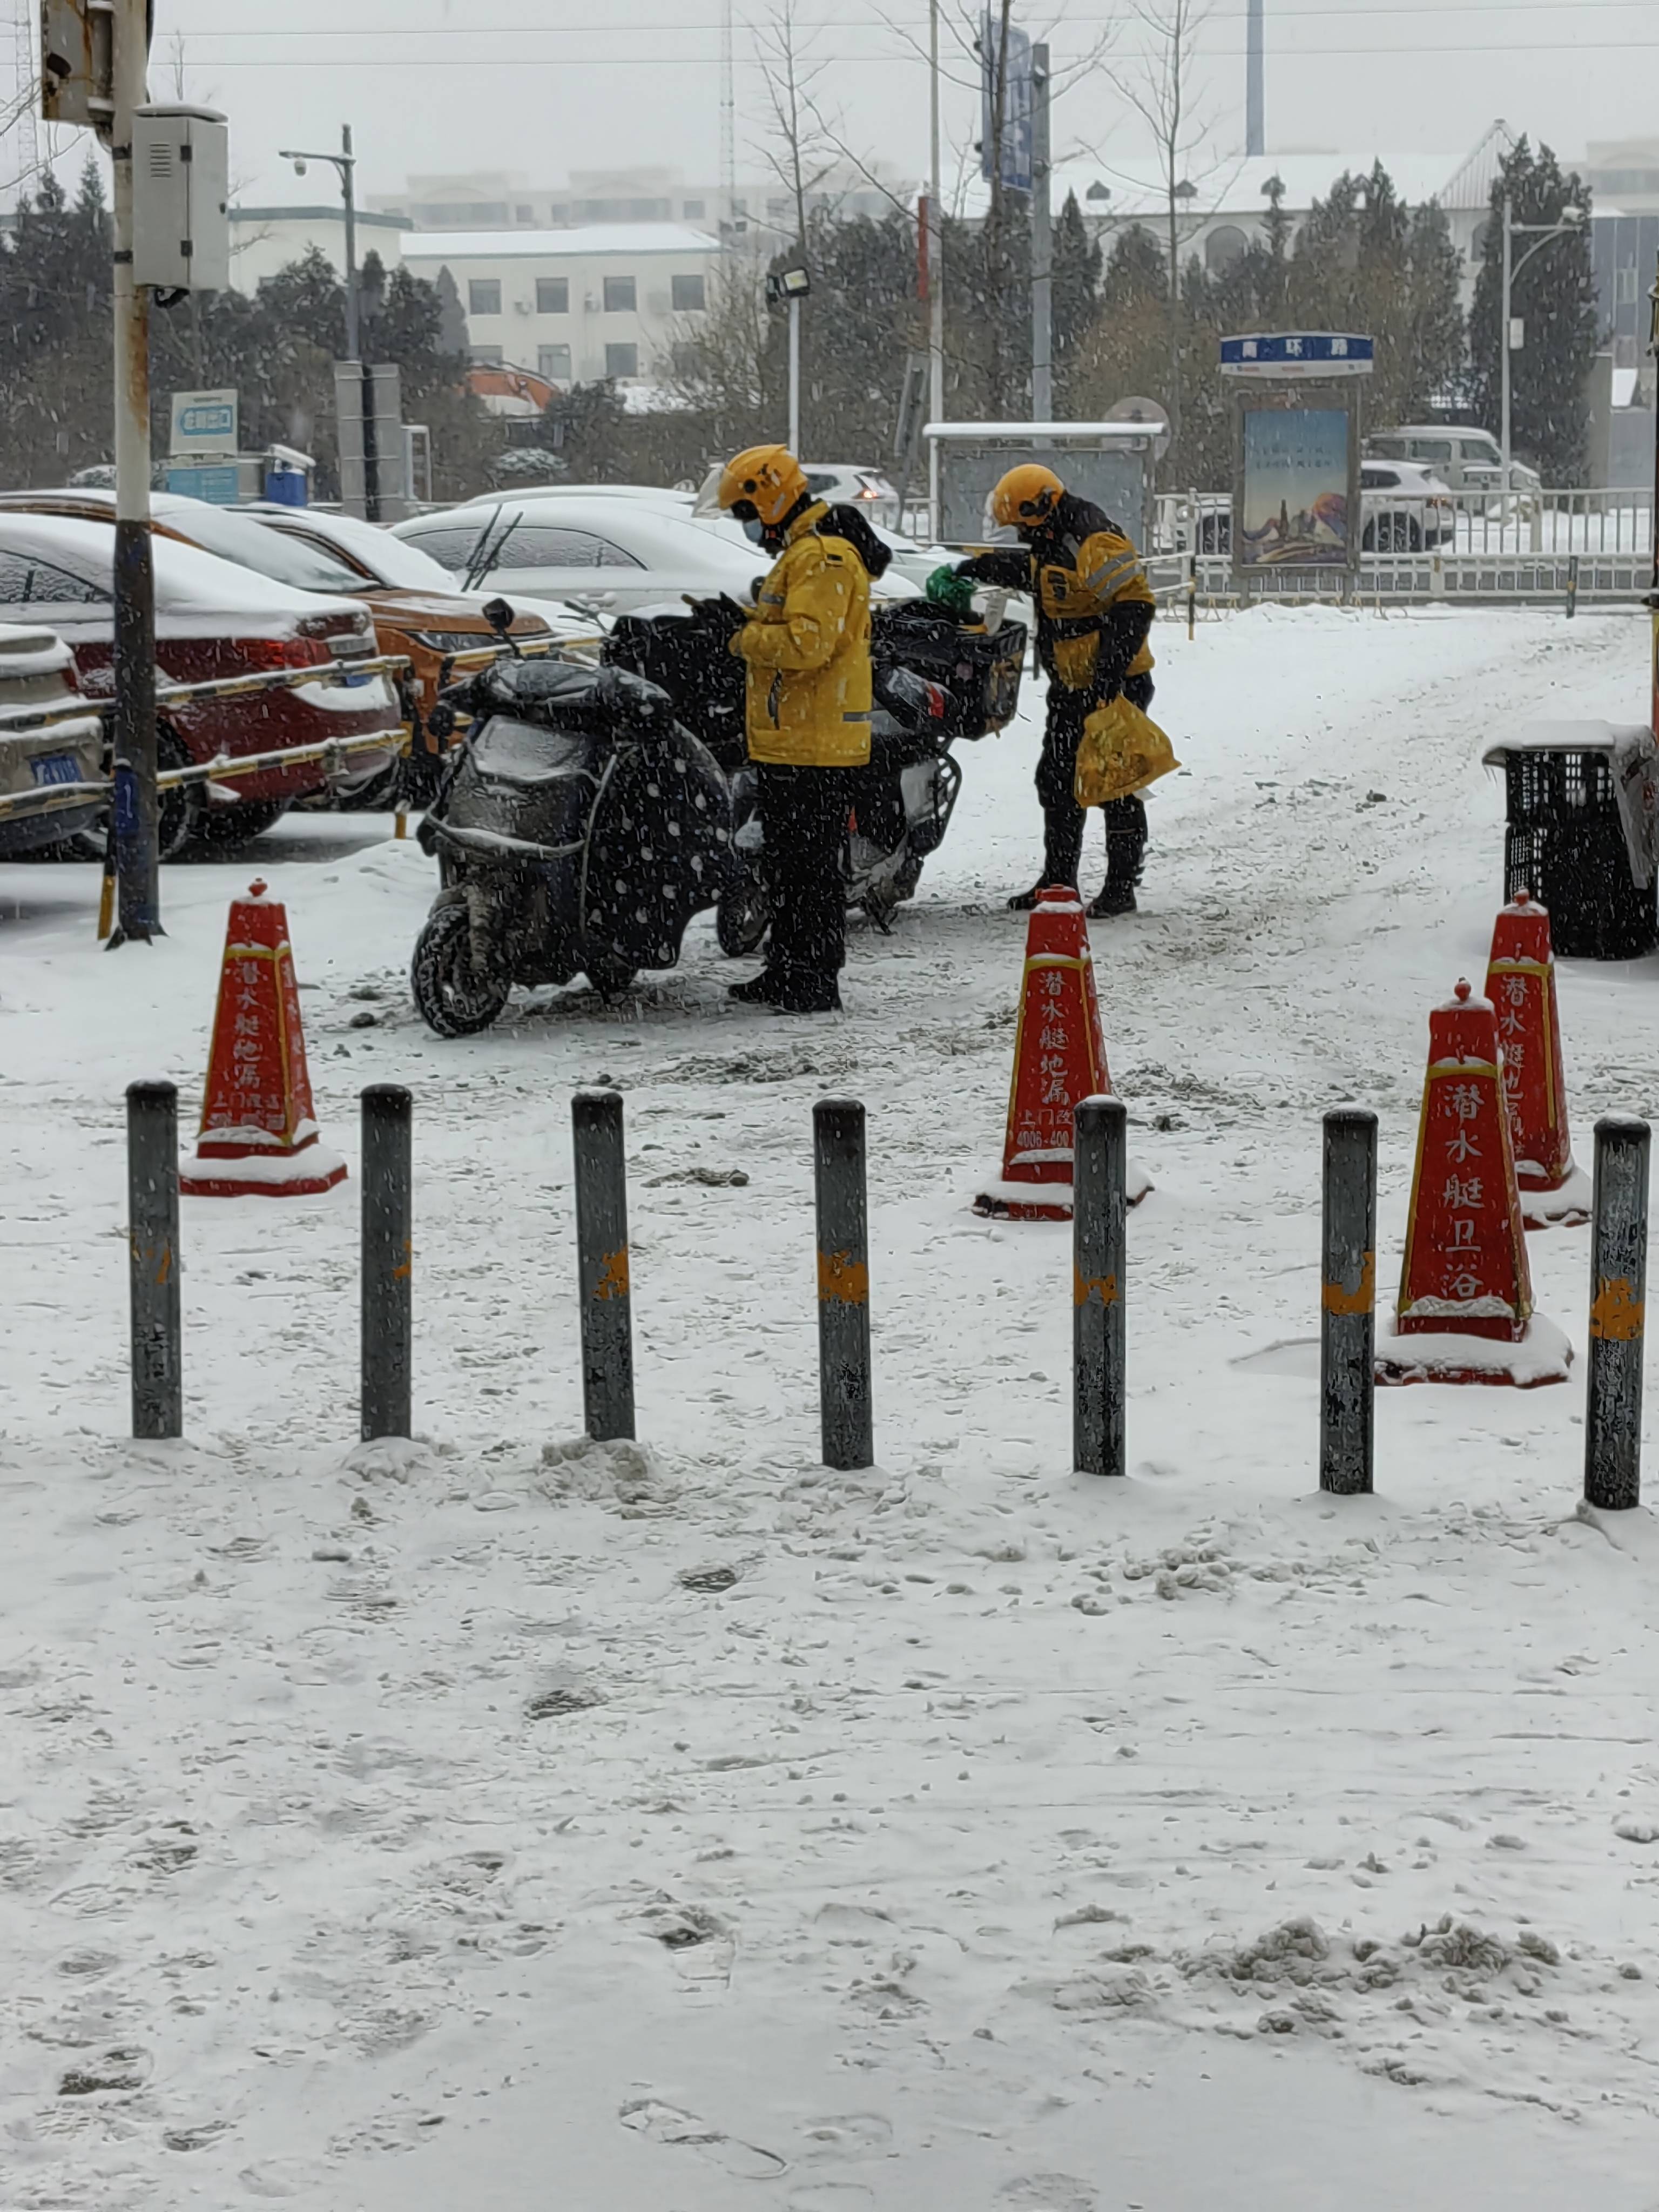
0,608 -> 1659,2212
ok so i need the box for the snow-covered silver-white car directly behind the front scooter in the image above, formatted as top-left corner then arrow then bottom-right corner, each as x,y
394,493 -> 787,613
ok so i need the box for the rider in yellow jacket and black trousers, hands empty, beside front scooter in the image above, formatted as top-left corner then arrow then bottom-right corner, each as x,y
719,444 -> 872,1013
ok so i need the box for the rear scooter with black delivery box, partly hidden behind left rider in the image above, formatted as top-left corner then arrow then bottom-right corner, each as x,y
604,599 -> 1027,955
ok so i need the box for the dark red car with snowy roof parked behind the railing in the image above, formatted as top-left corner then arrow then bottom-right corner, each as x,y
0,511 -> 402,856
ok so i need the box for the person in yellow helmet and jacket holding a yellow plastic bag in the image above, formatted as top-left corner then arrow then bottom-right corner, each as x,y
955,462 -> 1157,916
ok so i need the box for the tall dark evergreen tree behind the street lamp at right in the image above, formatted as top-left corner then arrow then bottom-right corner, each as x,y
1469,139 -> 1597,484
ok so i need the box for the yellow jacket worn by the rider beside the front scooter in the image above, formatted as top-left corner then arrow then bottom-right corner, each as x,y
732,500 -> 872,767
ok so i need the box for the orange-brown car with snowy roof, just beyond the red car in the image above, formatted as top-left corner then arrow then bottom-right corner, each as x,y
0,487 -> 595,792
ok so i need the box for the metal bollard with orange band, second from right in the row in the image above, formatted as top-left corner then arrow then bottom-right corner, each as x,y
1318,1106 -> 1376,1498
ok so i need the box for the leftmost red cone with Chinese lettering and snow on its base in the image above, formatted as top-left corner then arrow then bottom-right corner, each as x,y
179,882 -> 345,1199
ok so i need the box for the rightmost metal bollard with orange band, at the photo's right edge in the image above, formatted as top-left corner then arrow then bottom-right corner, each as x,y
1584,1112 -> 1653,1513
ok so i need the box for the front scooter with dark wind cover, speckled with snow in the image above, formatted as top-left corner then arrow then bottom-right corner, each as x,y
409,615 -> 732,1037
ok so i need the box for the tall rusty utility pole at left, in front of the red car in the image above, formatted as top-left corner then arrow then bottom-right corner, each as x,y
109,0 -> 161,947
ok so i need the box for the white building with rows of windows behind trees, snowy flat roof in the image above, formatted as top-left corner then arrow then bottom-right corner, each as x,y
402,224 -> 721,385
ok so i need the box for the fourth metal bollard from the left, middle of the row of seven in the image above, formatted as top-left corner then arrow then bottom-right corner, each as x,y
812,1100 -> 876,1467
